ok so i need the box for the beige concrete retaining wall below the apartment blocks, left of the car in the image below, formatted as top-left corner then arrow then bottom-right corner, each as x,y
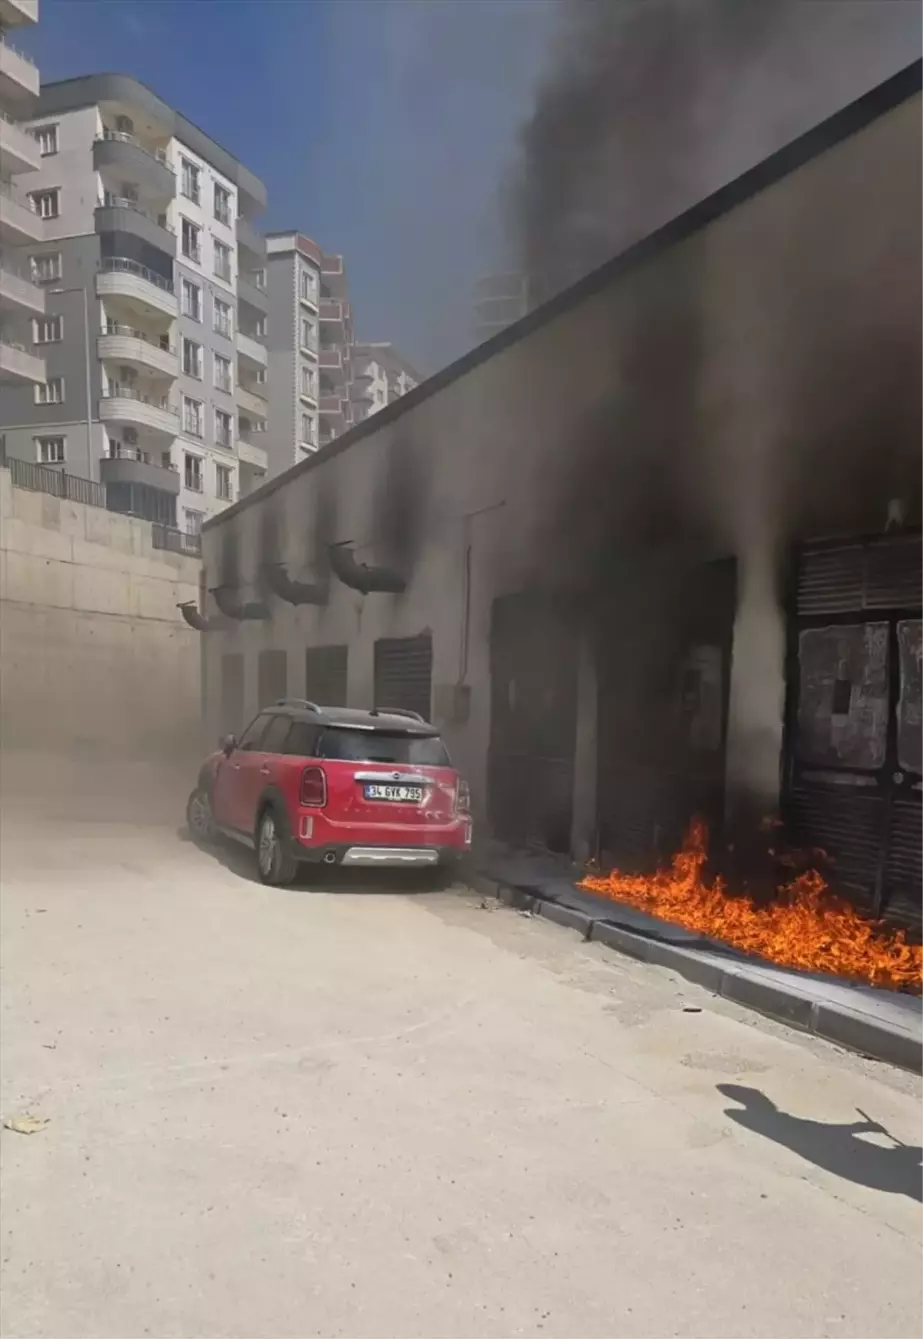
0,470 -> 201,761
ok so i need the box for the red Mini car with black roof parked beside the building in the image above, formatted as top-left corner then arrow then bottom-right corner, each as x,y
186,698 -> 472,885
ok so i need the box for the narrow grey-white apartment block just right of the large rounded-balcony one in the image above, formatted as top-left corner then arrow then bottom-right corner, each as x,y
267,233 -> 323,474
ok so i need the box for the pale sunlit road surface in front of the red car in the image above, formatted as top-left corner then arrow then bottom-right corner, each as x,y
0,765 -> 923,1339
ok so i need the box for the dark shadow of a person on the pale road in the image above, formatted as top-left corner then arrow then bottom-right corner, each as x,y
717,1083 -> 923,1204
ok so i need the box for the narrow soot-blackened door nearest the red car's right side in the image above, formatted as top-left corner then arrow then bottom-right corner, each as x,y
488,595 -> 577,852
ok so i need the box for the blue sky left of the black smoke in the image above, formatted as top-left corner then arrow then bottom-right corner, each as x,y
24,0 -> 553,371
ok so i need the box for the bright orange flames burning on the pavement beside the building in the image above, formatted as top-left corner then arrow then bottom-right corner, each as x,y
579,819 -> 923,990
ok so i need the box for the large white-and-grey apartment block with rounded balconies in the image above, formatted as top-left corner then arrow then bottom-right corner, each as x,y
0,73 -> 269,534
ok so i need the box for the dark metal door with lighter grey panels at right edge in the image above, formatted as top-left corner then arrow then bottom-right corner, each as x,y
785,534 -> 923,929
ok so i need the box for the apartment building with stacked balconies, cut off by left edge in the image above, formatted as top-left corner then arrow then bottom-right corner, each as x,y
0,0 -> 47,393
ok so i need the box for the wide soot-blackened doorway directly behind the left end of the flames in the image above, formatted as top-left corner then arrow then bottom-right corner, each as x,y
597,557 -> 735,872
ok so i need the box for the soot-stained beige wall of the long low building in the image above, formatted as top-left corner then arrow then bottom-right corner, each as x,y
204,89 -> 923,832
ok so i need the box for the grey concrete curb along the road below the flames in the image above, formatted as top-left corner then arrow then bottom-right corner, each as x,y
469,872 -> 923,1074
